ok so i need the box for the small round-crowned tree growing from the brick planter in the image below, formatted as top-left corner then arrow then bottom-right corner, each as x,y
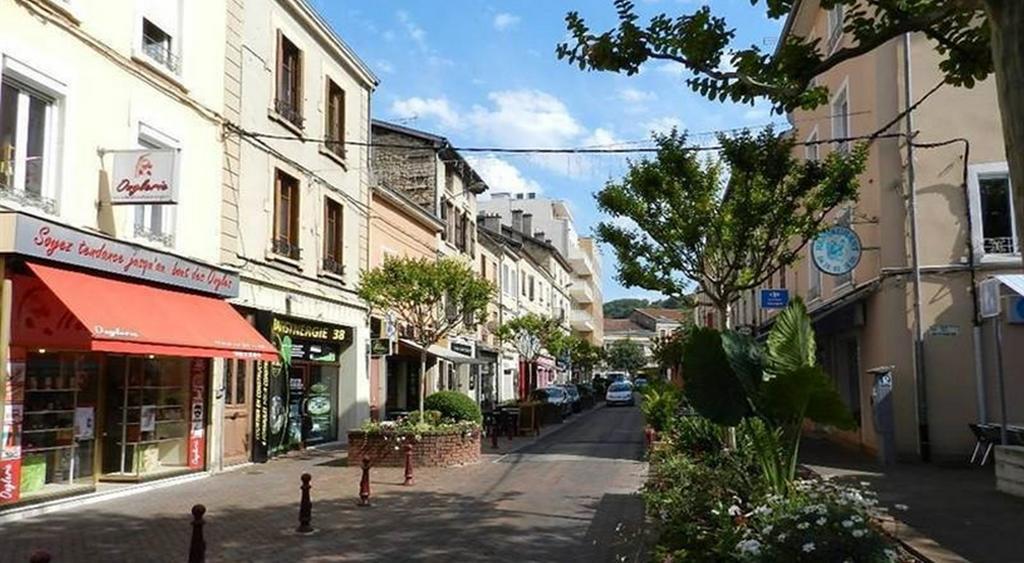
357,258 -> 495,416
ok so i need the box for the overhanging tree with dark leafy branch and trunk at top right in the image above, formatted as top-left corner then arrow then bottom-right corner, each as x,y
556,0 -> 1024,274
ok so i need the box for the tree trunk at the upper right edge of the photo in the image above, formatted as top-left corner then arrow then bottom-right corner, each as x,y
984,0 -> 1024,260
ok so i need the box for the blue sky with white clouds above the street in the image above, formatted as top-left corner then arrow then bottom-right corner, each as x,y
311,0 -> 784,300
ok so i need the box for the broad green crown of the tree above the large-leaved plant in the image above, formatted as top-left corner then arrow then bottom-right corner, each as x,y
597,129 -> 866,321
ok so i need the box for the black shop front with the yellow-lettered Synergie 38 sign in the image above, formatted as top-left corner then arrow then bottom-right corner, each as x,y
253,311 -> 353,462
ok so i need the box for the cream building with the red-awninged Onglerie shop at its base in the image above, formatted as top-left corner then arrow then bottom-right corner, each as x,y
0,0 -> 288,511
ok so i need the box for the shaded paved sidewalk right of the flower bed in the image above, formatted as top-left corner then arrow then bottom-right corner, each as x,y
801,439 -> 1024,563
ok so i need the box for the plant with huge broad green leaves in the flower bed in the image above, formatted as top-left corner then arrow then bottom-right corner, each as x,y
683,299 -> 856,493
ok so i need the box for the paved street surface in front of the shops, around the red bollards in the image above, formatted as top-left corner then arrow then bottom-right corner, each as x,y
0,407 -> 645,563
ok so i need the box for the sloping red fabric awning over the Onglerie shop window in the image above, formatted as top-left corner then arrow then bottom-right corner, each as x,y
11,264 -> 278,361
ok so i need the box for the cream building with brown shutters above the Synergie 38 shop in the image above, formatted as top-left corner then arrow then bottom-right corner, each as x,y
222,0 -> 377,461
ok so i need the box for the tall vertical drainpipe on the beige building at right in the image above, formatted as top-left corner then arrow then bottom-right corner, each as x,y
903,33 -> 931,462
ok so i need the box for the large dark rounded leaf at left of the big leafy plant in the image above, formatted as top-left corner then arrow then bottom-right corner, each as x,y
683,328 -> 751,426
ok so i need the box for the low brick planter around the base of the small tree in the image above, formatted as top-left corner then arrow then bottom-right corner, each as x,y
348,430 -> 480,468
